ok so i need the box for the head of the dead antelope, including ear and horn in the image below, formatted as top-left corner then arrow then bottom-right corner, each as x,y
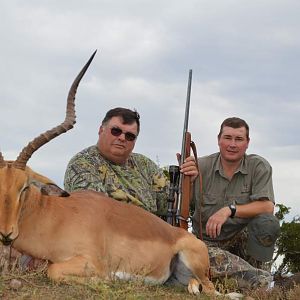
0,51 -> 96,245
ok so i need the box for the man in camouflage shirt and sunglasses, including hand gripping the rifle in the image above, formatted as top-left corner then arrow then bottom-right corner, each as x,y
64,108 -> 198,215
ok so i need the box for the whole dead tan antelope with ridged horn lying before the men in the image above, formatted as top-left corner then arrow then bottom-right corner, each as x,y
0,53 -> 214,294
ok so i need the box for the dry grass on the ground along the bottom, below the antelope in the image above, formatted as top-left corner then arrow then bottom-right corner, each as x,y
0,254 -> 300,300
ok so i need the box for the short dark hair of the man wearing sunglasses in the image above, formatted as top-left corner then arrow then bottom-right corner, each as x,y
102,107 -> 140,133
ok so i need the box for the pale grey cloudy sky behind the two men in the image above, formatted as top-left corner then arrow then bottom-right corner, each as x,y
0,0 -> 300,220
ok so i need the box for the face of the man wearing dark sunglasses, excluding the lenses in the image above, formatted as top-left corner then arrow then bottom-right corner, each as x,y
98,117 -> 138,164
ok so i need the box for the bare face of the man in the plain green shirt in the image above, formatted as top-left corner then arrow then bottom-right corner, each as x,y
218,126 -> 249,162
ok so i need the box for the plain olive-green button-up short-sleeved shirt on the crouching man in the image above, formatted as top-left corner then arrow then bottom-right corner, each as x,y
193,152 -> 274,241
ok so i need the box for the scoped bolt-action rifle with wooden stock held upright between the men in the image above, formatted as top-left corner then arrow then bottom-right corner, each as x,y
167,70 -> 197,229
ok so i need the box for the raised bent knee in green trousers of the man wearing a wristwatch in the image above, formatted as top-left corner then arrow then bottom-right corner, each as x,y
247,214 -> 280,262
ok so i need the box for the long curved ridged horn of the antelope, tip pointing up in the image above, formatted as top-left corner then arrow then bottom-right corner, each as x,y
13,50 -> 97,170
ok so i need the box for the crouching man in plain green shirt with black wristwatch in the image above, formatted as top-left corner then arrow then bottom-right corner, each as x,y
193,117 -> 279,268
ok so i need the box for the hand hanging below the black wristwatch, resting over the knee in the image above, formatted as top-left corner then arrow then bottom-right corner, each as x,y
206,207 -> 231,239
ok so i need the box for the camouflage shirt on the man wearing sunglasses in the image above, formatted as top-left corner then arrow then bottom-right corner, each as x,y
64,145 -> 168,215
